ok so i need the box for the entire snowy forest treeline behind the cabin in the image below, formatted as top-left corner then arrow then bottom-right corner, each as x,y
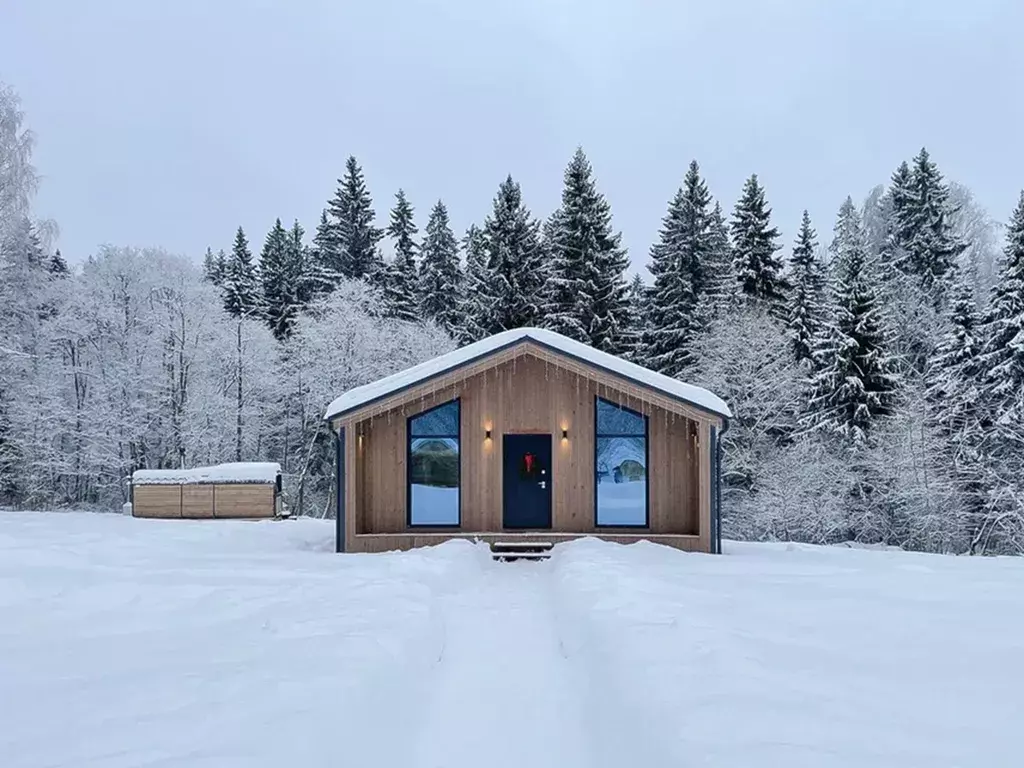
0,79 -> 1024,553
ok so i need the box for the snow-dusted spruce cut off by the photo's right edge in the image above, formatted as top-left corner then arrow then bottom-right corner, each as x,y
980,191 -> 1024,429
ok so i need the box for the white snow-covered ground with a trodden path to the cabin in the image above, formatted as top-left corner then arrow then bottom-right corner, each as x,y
0,513 -> 1024,768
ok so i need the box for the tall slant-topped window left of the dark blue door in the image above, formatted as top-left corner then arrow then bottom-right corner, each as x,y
407,400 -> 459,526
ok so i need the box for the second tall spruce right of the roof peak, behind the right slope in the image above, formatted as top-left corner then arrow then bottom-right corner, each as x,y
644,161 -> 715,376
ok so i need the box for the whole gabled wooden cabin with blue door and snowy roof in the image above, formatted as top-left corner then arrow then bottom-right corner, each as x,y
326,328 -> 730,553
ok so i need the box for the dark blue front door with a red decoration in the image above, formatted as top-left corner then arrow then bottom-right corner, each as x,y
502,434 -> 552,528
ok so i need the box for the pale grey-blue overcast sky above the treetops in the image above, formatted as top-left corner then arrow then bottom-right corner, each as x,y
0,0 -> 1024,274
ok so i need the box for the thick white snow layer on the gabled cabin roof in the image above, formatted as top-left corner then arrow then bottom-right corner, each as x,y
324,328 -> 732,419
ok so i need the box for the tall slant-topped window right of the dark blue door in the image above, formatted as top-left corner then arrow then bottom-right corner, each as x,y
594,397 -> 647,527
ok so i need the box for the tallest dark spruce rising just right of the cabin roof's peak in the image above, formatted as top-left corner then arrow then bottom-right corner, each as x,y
544,148 -> 629,354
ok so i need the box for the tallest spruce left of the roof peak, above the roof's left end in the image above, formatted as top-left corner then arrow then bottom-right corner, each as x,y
322,157 -> 383,282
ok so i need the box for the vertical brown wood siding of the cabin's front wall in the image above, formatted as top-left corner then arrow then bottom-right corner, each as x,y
345,354 -> 704,540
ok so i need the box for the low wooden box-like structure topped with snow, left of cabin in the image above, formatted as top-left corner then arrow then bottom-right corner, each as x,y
131,462 -> 282,520
